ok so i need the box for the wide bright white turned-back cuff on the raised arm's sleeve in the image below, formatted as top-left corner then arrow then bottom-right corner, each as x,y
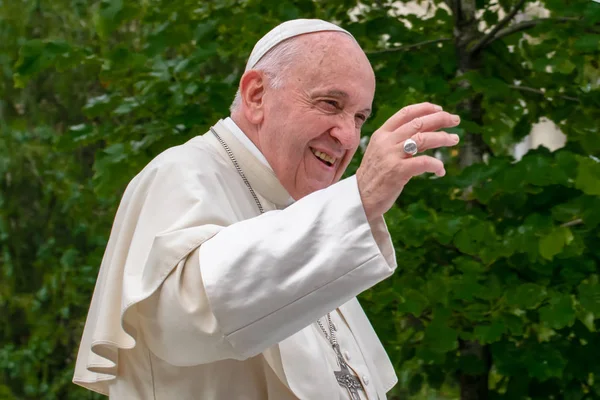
200,176 -> 396,357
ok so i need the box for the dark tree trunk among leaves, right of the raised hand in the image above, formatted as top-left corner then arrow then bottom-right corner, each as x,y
451,0 -> 491,400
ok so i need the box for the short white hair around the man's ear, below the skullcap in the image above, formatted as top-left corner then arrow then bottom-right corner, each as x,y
229,36 -> 302,113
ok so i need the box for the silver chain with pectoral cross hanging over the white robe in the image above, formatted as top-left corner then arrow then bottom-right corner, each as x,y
210,127 -> 363,400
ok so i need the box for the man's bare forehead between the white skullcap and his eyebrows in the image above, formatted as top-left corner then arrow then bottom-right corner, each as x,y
290,32 -> 375,105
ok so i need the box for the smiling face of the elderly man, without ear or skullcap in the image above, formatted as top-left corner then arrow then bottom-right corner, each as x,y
258,32 -> 375,200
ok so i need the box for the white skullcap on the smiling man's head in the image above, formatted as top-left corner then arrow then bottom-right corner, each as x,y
246,19 -> 354,71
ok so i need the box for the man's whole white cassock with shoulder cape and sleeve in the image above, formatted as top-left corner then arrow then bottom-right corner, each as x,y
73,119 -> 397,400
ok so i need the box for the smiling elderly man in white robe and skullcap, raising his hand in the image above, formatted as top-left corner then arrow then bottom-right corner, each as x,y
73,20 -> 458,400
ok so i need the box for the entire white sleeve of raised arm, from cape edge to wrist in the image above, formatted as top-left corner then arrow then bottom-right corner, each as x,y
137,177 -> 396,366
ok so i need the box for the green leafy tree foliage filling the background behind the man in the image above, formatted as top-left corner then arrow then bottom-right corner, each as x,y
0,0 -> 600,400
